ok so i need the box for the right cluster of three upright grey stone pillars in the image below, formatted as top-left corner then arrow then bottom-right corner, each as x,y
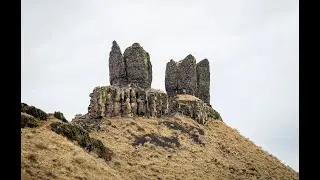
165,54 -> 210,105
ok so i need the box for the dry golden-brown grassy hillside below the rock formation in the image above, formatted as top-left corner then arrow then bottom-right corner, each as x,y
21,116 -> 299,180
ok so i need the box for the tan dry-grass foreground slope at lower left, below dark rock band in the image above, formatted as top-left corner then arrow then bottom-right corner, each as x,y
21,119 -> 123,180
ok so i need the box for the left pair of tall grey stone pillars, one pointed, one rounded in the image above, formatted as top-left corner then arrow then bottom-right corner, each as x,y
109,41 -> 152,89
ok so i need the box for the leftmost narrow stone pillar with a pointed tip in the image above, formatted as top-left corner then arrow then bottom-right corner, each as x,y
109,41 -> 128,86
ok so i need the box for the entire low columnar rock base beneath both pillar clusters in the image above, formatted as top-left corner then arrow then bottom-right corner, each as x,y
86,86 -> 217,124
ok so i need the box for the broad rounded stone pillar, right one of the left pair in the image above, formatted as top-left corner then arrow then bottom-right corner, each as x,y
123,43 -> 152,89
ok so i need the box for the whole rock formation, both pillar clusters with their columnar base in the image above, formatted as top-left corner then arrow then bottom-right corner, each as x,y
87,41 -> 219,124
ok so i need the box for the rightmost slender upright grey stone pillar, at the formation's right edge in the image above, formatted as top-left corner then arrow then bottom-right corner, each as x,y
196,59 -> 210,105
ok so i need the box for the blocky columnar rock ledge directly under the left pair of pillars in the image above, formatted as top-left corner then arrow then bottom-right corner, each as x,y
88,86 -> 168,119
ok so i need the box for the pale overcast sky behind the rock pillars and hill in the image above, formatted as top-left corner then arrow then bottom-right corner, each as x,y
21,0 -> 299,171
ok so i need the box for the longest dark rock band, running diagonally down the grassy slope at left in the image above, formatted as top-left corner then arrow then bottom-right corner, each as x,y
50,122 -> 114,161
